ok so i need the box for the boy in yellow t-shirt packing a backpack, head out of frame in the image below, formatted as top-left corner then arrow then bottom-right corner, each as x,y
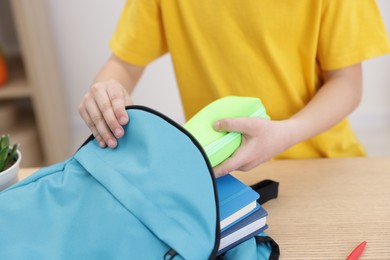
79,0 -> 390,176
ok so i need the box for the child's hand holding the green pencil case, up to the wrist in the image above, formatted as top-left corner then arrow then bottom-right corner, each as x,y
214,118 -> 292,177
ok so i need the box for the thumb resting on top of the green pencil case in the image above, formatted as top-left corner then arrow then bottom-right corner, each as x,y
214,118 -> 258,134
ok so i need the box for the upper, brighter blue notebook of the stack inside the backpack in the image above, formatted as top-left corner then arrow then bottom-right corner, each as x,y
216,174 -> 259,230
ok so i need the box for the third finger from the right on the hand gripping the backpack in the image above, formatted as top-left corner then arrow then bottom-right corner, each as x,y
86,97 -> 117,148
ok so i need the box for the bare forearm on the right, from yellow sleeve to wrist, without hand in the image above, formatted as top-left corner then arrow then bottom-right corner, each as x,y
288,64 -> 362,145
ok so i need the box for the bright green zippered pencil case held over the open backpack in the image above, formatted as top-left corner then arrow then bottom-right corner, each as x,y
183,96 -> 270,167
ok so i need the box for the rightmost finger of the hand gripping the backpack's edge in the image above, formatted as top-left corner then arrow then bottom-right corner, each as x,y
107,88 -> 131,128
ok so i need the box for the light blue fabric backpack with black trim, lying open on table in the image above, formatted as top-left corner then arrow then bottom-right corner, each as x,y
0,106 -> 279,260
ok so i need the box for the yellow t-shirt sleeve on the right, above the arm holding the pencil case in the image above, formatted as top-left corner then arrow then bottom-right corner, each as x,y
317,0 -> 390,70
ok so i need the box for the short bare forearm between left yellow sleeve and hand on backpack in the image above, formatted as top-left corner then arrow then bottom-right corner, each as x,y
93,55 -> 144,93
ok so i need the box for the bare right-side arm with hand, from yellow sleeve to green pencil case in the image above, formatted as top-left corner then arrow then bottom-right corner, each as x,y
214,64 -> 362,177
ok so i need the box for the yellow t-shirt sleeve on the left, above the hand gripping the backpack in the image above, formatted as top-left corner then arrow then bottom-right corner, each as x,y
110,0 -> 167,66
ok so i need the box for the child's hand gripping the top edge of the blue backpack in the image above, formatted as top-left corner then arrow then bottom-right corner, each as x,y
79,80 -> 133,148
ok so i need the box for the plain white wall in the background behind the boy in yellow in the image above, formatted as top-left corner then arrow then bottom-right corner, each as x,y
48,0 -> 390,154
